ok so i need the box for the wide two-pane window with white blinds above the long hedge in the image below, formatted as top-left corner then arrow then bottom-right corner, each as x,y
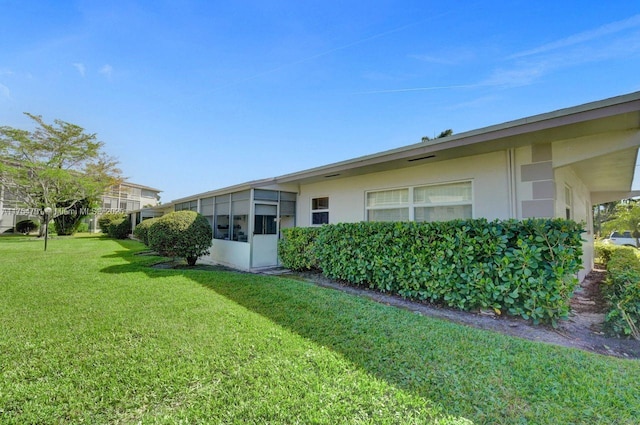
366,181 -> 473,222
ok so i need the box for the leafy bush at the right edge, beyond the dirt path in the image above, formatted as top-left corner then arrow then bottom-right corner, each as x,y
603,247 -> 640,339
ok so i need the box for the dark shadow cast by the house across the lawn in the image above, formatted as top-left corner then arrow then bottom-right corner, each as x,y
102,241 -> 640,423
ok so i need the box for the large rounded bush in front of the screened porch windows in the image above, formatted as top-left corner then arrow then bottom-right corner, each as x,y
147,211 -> 213,266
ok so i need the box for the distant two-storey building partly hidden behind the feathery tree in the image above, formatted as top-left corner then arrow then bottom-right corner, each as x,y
0,182 -> 161,234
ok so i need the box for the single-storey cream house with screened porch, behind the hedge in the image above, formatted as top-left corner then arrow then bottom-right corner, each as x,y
135,92 -> 640,278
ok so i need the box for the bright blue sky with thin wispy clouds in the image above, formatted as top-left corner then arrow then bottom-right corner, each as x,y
0,0 -> 640,202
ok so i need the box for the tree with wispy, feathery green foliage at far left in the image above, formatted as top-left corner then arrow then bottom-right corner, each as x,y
0,112 -> 121,235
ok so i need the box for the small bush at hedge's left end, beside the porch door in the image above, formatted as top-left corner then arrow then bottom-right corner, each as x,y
278,227 -> 320,271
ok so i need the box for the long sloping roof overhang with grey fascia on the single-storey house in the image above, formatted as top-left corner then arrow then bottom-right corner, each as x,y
161,92 -> 640,209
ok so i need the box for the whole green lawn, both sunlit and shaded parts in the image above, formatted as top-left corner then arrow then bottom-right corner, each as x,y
0,237 -> 640,424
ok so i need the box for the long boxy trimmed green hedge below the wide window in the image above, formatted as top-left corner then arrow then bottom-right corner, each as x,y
280,219 -> 583,323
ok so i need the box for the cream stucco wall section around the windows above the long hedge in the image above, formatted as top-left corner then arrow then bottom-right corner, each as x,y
297,151 -> 510,227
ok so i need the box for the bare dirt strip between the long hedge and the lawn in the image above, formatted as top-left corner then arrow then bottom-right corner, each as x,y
282,270 -> 640,359
